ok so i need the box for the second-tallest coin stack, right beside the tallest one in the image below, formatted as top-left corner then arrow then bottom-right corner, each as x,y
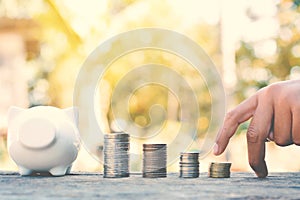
143,144 -> 167,178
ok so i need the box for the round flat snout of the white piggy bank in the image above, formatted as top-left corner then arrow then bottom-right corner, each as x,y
18,118 -> 56,149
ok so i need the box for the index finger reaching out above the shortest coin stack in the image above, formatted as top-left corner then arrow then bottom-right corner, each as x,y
214,94 -> 257,155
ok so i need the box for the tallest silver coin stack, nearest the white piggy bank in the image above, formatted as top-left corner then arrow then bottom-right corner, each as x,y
103,133 -> 130,178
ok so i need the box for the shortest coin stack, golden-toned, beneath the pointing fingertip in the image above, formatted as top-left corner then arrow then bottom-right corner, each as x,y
209,162 -> 231,178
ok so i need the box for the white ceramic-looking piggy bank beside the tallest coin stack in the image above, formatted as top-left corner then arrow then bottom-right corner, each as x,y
7,106 -> 80,176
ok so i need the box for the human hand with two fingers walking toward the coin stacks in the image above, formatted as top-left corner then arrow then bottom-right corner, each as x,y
214,80 -> 300,178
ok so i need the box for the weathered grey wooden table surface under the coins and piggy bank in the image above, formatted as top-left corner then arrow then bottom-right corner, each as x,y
0,172 -> 300,200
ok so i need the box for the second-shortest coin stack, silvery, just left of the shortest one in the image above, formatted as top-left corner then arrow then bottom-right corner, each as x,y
179,152 -> 199,178
